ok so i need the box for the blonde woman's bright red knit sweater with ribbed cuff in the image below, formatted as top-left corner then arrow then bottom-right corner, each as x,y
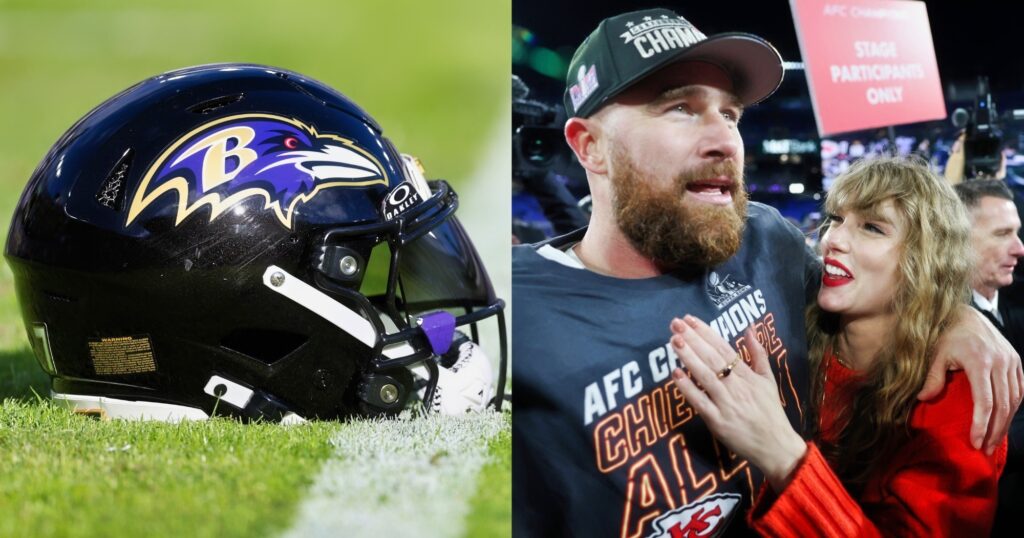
748,358 -> 1007,537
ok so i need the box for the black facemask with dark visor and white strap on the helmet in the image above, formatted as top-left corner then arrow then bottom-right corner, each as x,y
272,181 -> 507,414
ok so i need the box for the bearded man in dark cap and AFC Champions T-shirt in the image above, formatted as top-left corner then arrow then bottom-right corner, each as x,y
512,9 -> 1021,537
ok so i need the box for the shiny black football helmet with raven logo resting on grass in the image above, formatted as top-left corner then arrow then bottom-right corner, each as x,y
6,64 -> 507,420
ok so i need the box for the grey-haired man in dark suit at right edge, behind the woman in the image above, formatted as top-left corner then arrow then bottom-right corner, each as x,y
955,179 -> 1024,534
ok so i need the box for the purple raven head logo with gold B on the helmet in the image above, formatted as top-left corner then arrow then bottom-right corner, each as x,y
125,114 -> 388,229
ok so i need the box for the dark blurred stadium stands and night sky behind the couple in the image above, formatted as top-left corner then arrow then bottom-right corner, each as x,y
512,0 -> 1024,240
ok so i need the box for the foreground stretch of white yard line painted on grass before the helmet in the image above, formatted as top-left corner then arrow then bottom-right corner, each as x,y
284,412 -> 505,538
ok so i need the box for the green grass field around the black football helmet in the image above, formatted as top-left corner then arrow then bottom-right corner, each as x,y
0,0 -> 511,537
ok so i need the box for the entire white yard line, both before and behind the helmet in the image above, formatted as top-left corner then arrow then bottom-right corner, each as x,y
284,114 -> 512,538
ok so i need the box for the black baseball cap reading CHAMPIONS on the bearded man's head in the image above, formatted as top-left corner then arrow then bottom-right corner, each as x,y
564,8 -> 783,118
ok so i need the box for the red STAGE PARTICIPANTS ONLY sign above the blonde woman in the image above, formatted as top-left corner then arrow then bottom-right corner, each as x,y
790,0 -> 946,136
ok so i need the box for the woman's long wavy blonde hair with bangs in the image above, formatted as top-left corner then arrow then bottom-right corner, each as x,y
807,158 -> 973,491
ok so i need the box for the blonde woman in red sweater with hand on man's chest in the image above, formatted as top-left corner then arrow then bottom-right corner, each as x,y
672,158 -> 1006,536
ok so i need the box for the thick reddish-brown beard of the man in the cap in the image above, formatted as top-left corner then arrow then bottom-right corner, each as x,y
610,151 -> 746,270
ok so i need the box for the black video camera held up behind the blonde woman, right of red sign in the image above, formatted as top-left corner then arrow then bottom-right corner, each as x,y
952,77 -> 1002,178
